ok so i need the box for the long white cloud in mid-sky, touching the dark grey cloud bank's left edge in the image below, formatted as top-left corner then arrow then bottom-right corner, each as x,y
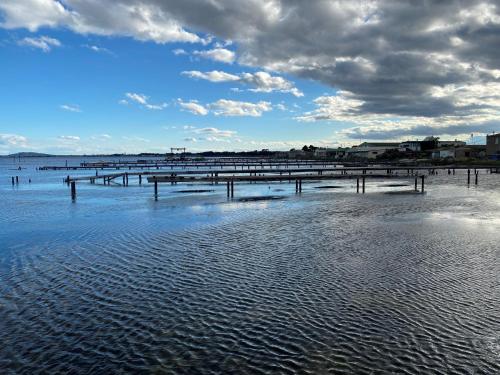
182,70 -> 304,97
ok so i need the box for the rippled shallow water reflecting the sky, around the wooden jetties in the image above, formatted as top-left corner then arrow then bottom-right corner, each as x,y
0,158 -> 500,374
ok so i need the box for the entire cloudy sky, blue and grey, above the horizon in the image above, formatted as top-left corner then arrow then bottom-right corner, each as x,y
0,0 -> 500,154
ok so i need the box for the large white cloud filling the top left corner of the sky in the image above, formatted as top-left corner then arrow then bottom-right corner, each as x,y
0,0 -> 204,43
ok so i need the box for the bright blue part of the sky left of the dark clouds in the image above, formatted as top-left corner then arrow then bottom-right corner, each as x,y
0,28 -> 335,153
